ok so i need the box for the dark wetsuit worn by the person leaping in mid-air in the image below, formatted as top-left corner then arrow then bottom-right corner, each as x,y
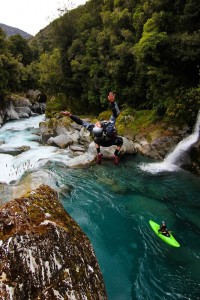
70,102 -> 123,147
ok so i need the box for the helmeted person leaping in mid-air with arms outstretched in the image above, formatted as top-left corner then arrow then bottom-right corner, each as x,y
60,92 -> 123,165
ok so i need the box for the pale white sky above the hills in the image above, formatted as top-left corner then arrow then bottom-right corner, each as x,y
0,0 -> 87,35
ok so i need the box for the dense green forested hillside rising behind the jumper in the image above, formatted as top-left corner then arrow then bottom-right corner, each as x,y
0,0 -> 200,123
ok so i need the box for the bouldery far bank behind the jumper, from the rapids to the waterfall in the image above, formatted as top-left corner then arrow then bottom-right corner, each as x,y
39,117 -> 200,175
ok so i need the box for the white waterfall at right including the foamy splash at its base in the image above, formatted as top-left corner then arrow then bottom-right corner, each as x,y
139,110 -> 200,174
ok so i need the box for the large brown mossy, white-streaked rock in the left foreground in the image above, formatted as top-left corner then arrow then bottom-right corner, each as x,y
0,185 -> 107,300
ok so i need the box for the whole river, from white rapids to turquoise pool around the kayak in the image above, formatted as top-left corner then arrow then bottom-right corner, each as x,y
0,116 -> 200,300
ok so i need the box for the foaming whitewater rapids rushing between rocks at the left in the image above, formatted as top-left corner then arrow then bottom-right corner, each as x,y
0,115 -> 68,184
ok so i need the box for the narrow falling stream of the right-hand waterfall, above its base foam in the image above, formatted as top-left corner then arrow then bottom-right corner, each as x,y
164,111 -> 200,165
